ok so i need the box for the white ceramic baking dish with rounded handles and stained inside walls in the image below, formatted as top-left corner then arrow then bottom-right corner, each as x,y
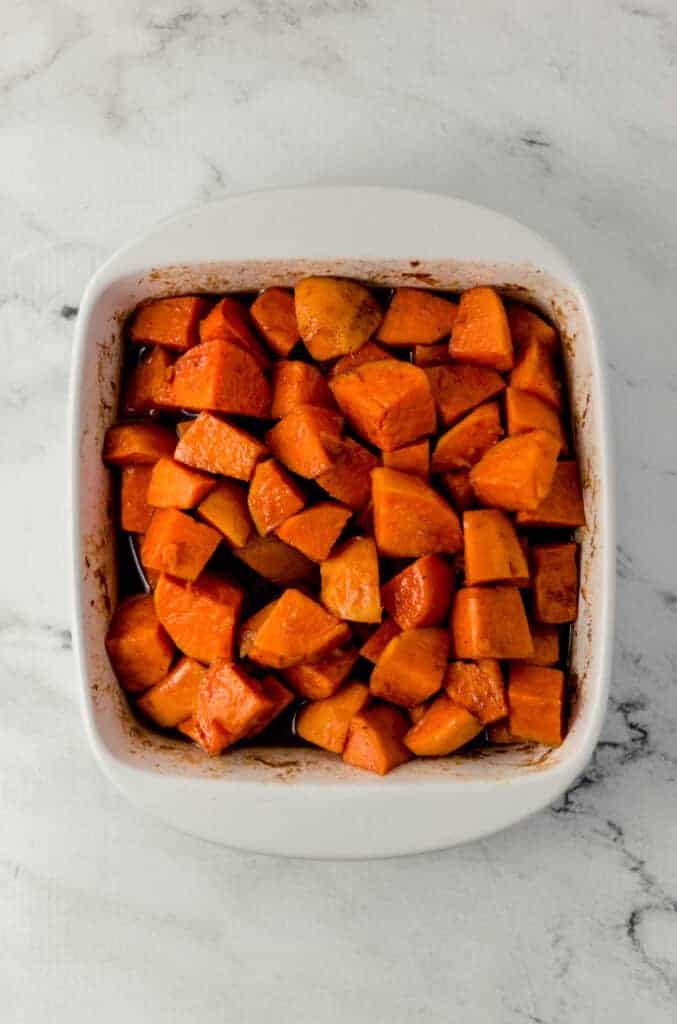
71,187 -> 615,858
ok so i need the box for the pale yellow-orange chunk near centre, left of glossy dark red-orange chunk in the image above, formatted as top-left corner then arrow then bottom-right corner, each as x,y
320,537 -> 381,623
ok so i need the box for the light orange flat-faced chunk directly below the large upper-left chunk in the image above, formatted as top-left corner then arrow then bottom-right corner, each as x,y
174,413 -> 267,480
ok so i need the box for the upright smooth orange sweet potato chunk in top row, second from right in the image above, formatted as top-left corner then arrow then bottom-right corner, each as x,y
450,288 -> 513,372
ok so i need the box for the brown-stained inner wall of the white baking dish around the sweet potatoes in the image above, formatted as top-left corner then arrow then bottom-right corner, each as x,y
80,260 -> 601,780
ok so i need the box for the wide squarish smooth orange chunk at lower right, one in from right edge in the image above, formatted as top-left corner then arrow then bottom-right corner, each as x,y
451,587 -> 534,658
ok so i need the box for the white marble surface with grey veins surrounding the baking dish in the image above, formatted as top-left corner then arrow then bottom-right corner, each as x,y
0,0 -> 677,1024
